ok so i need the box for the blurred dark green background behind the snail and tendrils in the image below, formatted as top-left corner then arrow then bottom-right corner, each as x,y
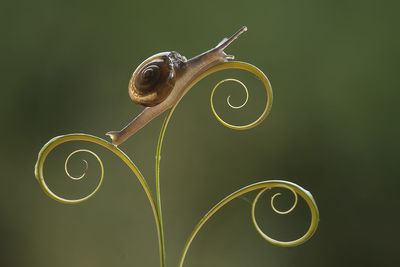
0,0 -> 400,267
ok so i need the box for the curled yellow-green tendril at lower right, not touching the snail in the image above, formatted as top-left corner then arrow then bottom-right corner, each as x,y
179,180 -> 319,267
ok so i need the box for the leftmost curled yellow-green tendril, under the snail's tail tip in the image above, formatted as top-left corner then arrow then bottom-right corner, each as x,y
35,133 -> 164,267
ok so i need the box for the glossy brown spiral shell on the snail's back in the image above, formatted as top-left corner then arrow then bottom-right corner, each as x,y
129,51 -> 187,107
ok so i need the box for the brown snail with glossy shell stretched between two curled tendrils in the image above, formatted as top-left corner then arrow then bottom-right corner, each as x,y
106,26 -> 247,146
